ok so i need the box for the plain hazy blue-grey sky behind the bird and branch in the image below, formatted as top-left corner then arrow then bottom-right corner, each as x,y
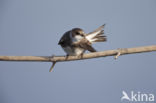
0,0 -> 156,103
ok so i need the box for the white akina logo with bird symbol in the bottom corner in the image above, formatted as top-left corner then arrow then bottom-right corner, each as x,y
121,91 -> 154,102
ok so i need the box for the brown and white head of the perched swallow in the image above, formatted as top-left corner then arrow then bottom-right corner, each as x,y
71,28 -> 85,40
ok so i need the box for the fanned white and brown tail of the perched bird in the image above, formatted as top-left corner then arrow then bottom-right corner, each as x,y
86,24 -> 107,43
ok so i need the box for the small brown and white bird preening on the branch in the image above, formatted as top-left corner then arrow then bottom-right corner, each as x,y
58,24 -> 107,56
